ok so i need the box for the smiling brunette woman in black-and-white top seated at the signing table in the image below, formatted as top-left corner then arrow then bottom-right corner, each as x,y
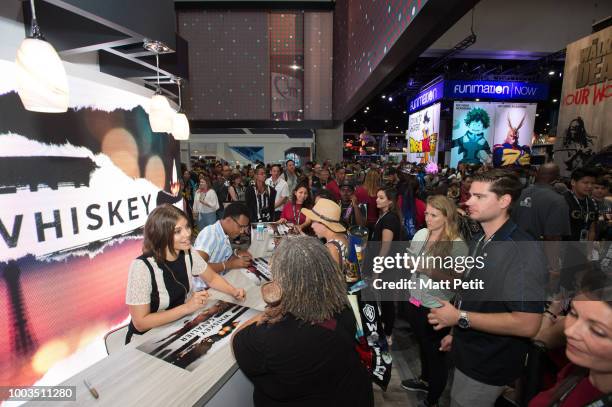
125,204 -> 245,343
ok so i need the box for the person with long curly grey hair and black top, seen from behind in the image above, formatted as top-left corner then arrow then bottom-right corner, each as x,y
232,236 -> 374,407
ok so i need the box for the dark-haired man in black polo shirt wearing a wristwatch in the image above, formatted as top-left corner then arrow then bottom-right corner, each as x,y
428,169 -> 546,407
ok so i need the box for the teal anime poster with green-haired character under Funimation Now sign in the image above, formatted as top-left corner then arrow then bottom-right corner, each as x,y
451,102 -> 495,167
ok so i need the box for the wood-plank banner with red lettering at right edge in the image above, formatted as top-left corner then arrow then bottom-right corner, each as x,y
554,27 -> 612,176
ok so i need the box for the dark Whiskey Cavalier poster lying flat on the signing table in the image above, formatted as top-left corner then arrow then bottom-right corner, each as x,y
137,301 -> 258,372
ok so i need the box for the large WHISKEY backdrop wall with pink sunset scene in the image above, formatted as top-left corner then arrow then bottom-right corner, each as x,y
0,78 -> 182,386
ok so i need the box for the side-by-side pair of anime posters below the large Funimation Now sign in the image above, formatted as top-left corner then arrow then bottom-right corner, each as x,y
451,102 -> 537,167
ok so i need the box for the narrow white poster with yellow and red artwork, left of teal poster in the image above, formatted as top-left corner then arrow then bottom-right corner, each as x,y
407,103 -> 440,164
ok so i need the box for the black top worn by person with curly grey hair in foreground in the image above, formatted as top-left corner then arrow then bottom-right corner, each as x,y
233,308 -> 374,407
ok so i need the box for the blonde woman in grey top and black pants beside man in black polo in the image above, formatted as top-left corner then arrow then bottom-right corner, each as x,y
402,195 -> 468,406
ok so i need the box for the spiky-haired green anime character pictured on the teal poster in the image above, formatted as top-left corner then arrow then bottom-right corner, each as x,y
452,107 -> 491,164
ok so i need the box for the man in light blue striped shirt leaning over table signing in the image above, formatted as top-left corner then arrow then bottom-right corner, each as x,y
193,203 -> 253,273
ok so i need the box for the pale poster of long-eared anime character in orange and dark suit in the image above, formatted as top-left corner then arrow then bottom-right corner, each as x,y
493,103 -> 537,167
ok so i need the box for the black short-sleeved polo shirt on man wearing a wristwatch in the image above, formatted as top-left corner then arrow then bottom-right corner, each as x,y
452,220 -> 547,386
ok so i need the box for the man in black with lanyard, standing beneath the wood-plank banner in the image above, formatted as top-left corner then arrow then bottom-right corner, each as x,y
561,168 -> 599,295
